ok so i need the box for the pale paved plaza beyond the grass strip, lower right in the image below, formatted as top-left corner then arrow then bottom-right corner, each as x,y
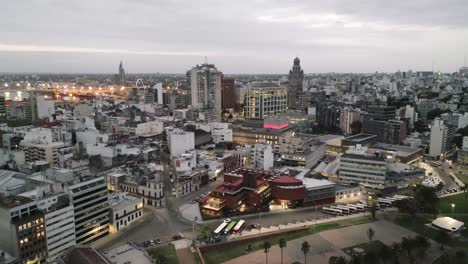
225,220 -> 442,264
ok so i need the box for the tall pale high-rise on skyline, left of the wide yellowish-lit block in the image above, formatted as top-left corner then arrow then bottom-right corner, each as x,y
187,63 -> 222,117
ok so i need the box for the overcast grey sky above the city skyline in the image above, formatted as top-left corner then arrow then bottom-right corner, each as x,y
0,0 -> 468,74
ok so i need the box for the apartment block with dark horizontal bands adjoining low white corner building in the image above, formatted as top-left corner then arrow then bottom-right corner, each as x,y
67,177 -> 109,244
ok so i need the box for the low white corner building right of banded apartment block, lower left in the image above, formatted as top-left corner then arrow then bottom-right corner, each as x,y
109,192 -> 143,234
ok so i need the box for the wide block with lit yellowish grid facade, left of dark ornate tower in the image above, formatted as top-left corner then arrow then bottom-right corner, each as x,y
244,84 -> 288,119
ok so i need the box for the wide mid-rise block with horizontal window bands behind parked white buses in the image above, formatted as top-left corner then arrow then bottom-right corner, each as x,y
338,148 -> 387,188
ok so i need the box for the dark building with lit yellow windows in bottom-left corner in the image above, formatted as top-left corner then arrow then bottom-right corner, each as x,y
0,196 -> 47,263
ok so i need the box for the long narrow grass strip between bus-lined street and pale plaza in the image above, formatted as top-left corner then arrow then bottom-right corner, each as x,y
203,216 -> 371,264
